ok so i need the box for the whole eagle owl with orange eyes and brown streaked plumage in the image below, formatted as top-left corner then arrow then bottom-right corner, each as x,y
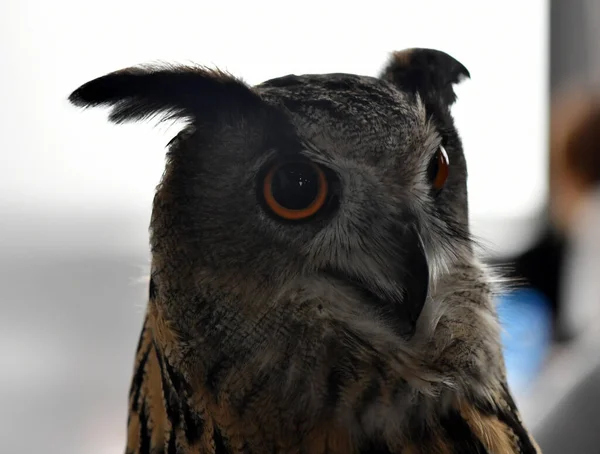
69,49 -> 539,454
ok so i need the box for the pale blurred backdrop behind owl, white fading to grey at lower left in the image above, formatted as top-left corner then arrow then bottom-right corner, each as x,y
0,0 -> 548,454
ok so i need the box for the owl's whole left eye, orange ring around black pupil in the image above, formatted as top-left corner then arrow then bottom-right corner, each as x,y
263,161 -> 328,221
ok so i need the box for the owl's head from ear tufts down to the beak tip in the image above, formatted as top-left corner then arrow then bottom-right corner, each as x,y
72,50 -> 470,336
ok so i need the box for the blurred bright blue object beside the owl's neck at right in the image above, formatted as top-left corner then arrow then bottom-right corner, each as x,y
497,288 -> 552,394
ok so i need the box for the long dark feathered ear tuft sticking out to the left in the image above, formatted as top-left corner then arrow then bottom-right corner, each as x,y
69,65 -> 261,123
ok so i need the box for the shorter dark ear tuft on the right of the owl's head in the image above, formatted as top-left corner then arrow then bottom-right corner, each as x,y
379,48 -> 471,106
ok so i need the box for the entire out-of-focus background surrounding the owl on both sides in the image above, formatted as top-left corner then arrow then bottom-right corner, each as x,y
0,0 -> 600,454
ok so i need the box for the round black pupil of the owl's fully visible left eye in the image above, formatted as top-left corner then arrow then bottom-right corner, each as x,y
271,163 -> 319,210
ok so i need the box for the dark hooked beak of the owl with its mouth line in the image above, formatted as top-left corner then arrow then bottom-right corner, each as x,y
326,228 -> 429,339
